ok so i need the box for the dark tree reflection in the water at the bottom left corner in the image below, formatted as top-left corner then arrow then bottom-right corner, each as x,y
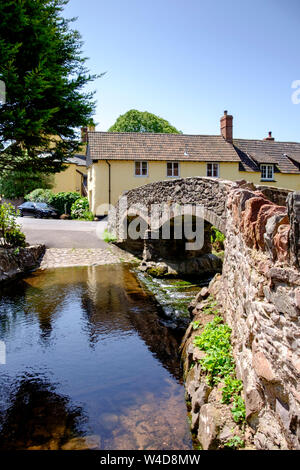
0,377 -> 86,450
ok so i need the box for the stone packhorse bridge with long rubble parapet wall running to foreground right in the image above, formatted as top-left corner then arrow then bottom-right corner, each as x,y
111,178 -> 300,449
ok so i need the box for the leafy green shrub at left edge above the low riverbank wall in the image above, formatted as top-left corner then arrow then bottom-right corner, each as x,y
0,204 -> 26,248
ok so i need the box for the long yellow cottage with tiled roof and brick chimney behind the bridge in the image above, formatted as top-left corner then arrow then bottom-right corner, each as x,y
87,111 -> 300,216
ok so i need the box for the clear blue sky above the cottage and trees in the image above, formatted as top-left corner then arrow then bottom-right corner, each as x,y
65,0 -> 300,141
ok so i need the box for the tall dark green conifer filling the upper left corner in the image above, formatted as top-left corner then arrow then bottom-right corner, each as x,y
0,0 -> 96,173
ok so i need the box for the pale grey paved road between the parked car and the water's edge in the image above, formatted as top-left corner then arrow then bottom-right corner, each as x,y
18,217 -> 107,248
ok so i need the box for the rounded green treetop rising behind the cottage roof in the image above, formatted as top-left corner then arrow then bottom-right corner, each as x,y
108,109 -> 181,134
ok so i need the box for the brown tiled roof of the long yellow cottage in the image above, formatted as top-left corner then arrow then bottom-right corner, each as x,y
88,132 -> 300,173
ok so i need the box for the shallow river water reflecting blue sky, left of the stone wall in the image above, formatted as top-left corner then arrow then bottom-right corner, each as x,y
0,265 -> 202,450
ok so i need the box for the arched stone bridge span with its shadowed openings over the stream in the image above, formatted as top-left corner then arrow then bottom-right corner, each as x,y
109,177 -> 234,271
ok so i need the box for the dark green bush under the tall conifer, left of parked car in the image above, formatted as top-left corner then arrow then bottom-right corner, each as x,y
0,170 -> 52,199
